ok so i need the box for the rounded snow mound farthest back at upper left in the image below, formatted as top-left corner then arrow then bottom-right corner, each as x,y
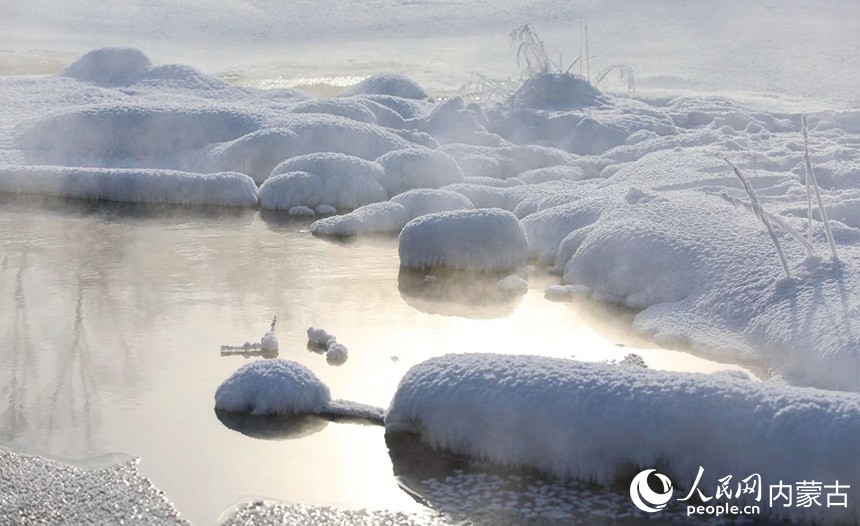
60,48 -> 152,87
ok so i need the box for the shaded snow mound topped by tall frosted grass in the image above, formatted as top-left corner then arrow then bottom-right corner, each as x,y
508,73 -> 608,110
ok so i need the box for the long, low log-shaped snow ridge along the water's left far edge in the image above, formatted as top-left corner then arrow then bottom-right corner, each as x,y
0,166 -> 257,207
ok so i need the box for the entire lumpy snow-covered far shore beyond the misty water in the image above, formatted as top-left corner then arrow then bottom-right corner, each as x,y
6,49 -> 860,391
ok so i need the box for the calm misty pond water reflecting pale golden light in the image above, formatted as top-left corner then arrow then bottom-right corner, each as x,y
0,199 -> 748,524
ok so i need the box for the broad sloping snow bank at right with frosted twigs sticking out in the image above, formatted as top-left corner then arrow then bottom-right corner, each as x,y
508,147 -> 860,391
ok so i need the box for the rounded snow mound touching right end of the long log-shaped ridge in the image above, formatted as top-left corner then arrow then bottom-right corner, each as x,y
260,152 -> 388,210
